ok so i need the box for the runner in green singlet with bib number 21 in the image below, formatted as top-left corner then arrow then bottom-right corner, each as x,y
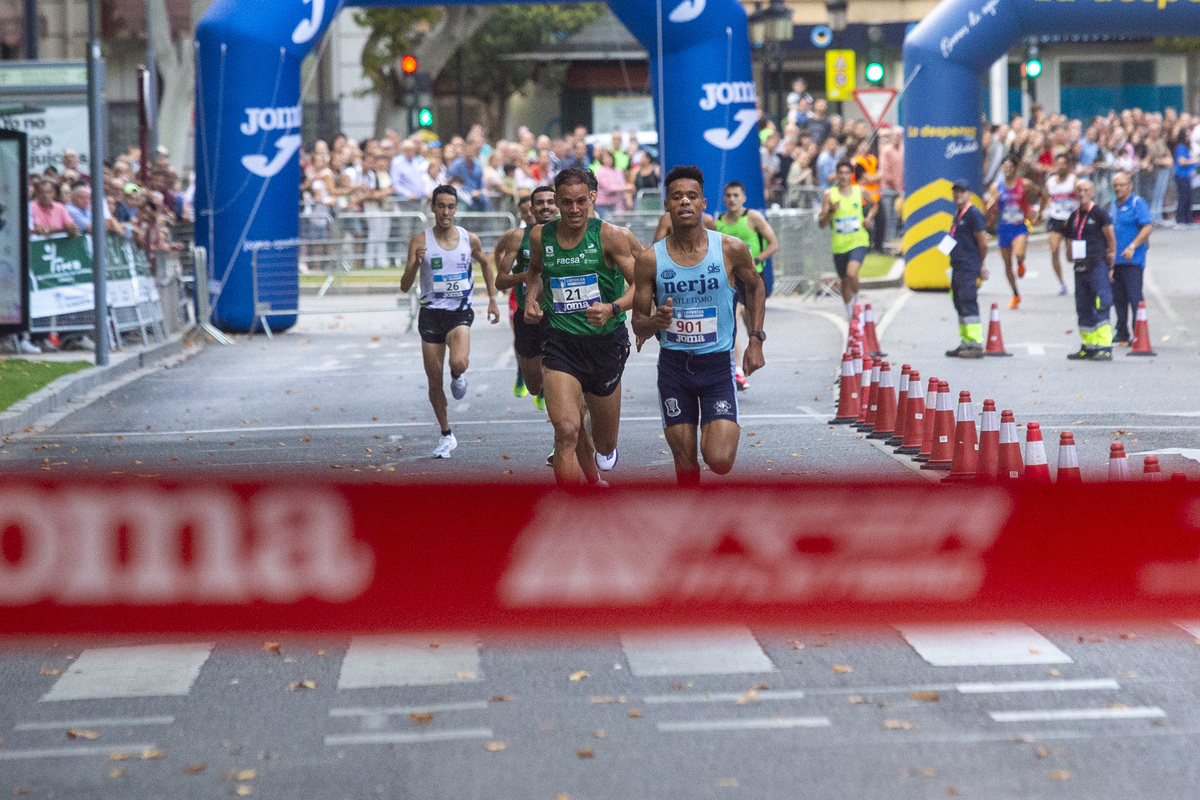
524,167 -> 634,486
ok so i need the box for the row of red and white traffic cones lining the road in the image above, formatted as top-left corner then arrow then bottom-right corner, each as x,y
829,306 -> 1186,483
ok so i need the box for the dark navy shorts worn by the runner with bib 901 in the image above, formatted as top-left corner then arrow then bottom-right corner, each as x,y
659,348 -> 738,428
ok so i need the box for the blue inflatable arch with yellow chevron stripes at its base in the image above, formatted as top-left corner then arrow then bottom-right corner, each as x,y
904,0 -> 1200,289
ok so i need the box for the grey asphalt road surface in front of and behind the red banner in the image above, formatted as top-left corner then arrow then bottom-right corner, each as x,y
0,230 -> 1200,800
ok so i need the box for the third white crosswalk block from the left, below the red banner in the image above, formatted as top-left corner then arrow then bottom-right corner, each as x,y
620,627 -> 776,676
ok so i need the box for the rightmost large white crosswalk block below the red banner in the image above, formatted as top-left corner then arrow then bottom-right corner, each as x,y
895,622 -> 1072,667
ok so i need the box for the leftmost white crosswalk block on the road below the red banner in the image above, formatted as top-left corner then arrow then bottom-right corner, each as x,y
42,643 -> 215,702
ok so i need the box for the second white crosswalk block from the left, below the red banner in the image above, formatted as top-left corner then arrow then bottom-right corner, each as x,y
337,636 -> 481,688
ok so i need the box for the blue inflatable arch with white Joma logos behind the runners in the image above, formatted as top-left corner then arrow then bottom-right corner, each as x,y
196,0 -> 762,331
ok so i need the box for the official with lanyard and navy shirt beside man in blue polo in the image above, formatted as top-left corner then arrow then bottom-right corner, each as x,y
1067,180 -> 1117,361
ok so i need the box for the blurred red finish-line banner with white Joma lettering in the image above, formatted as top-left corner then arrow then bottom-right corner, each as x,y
0,476 -> 1200,634
